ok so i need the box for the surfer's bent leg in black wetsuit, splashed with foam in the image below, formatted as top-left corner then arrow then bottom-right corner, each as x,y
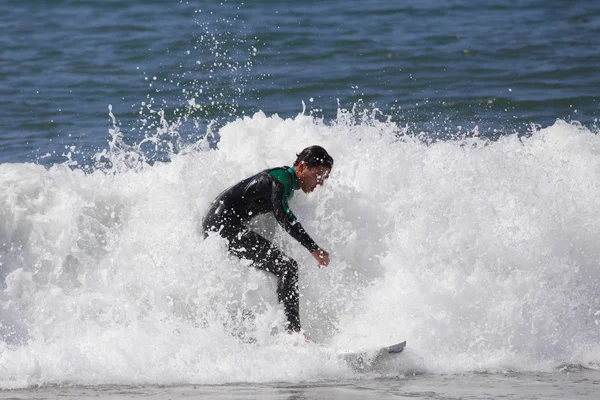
229,231 -> 300,331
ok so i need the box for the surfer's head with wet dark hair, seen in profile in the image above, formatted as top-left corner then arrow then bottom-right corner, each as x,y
294,146 -> 333,193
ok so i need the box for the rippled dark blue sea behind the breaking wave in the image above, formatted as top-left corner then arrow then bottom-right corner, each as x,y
0,0 -> 600,164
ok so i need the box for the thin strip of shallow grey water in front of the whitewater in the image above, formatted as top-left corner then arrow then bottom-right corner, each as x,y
0,371 -> 599,400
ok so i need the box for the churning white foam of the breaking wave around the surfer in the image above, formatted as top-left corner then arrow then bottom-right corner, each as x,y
0,111 -> 600,388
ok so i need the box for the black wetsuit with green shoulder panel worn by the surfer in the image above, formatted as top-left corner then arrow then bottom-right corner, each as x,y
202,167 -> 319,331
